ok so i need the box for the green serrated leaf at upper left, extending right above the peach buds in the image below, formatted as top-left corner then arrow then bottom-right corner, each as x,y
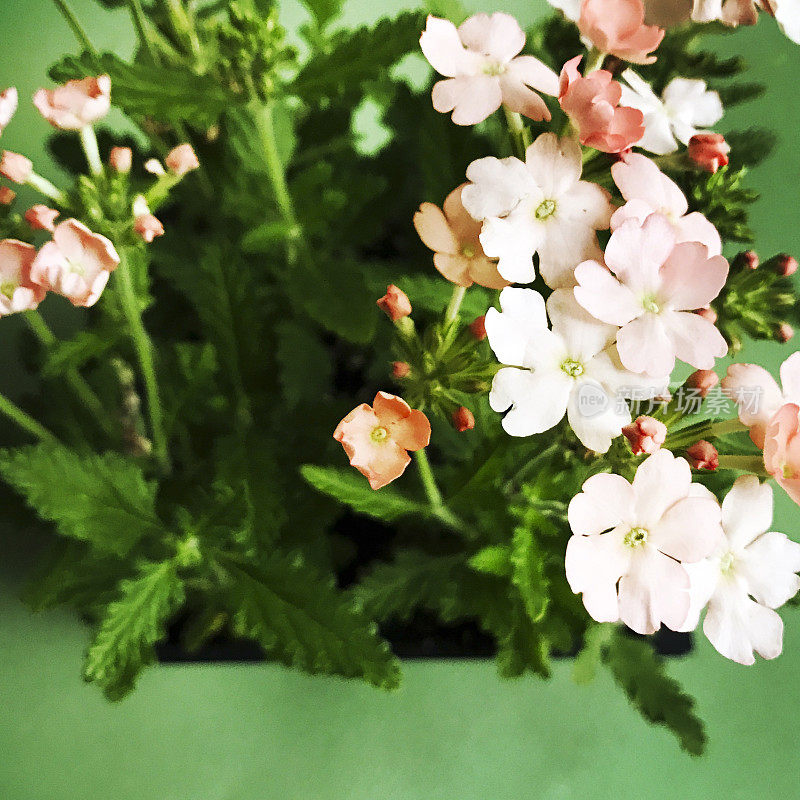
50,52 -> 235,127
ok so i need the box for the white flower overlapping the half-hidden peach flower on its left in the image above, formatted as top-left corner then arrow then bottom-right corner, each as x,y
461,133 -> 614,288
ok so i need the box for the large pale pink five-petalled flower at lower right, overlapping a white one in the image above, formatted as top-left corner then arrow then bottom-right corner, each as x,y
566,450 -> 722,634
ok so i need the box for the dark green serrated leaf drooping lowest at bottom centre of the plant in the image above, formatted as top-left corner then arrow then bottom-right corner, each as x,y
217,552 -> 400,689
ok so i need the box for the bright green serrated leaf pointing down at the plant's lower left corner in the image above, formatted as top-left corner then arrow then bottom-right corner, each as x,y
83,561 -> 184,700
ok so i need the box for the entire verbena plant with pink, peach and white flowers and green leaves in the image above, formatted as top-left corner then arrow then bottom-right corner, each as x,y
0,0 -> 800,754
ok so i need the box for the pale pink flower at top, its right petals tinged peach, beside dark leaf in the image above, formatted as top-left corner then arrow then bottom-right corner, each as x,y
419,13 -> 558,125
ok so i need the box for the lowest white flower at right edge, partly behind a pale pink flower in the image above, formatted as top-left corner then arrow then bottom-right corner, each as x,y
681,475 -> 800,664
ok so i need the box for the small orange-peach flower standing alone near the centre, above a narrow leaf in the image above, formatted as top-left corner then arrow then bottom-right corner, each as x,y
333,392 -> 431,489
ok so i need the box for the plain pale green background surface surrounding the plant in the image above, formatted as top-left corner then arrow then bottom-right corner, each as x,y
0,0 -> 800,800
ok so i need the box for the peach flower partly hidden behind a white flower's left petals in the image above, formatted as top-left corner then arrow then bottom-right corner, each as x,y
414,184 -> 508,289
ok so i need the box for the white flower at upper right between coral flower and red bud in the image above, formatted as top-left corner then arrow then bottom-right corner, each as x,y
620,69 -> 723,155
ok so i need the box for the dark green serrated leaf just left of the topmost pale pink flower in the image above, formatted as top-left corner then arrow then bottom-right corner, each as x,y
288,11 -> 425,103
